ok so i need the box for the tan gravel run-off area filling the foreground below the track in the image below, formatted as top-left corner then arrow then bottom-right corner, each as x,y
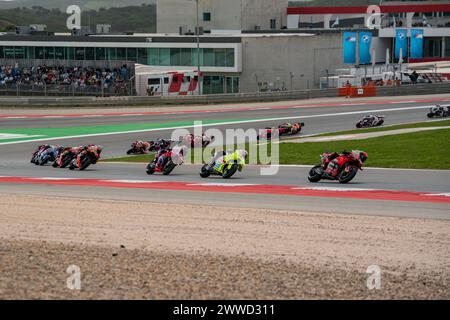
0,194 -> 450,299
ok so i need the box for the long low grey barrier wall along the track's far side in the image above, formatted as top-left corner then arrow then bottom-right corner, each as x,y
0,82 -> 450,107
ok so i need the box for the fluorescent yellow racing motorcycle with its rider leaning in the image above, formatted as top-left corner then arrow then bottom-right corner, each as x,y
200,151 -> 246,179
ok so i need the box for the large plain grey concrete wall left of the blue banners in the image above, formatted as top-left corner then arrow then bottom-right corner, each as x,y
240,33 -> 344,93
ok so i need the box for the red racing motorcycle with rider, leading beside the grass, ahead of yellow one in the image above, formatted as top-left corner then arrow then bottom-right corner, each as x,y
308,150 -> 367,183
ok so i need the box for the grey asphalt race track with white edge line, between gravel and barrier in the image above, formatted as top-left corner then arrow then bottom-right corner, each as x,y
0,99 -> 450,219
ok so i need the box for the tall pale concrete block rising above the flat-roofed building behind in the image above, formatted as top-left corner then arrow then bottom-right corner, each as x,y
156,0 -> 288,33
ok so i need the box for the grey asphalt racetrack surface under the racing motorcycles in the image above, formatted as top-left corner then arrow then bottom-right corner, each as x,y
0,97 -> 450,218
